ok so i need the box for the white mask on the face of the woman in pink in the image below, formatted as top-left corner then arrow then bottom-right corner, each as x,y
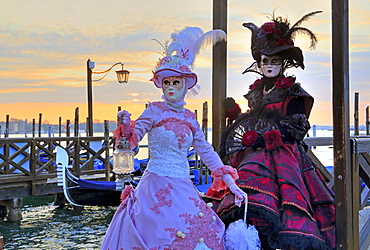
162,76 -> 186,102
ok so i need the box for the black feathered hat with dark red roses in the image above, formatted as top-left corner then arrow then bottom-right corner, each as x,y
243,11 -> 322,73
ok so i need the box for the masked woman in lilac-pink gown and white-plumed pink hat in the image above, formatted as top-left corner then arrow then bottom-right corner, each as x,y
101,27 -> 243,250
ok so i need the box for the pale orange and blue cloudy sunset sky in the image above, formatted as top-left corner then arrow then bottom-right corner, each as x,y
0,0 -> 370,125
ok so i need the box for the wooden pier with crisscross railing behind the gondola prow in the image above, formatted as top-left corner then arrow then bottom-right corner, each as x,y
0,121 -> 113,221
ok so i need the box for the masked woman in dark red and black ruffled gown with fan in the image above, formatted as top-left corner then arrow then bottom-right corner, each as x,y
206,11 -> 336,249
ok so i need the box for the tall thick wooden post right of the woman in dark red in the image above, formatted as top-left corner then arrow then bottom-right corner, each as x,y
331,0 -> 359,250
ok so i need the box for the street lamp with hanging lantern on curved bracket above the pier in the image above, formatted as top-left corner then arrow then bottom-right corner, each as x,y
87,59 -> 130,136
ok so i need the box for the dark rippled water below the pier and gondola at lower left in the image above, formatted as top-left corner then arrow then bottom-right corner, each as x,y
0,196 -> 117,250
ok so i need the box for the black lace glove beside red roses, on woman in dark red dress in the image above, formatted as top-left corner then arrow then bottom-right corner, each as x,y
280,114 -> 311,141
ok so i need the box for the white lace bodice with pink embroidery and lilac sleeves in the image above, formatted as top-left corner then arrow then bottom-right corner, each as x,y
134,102 -> 223,178
